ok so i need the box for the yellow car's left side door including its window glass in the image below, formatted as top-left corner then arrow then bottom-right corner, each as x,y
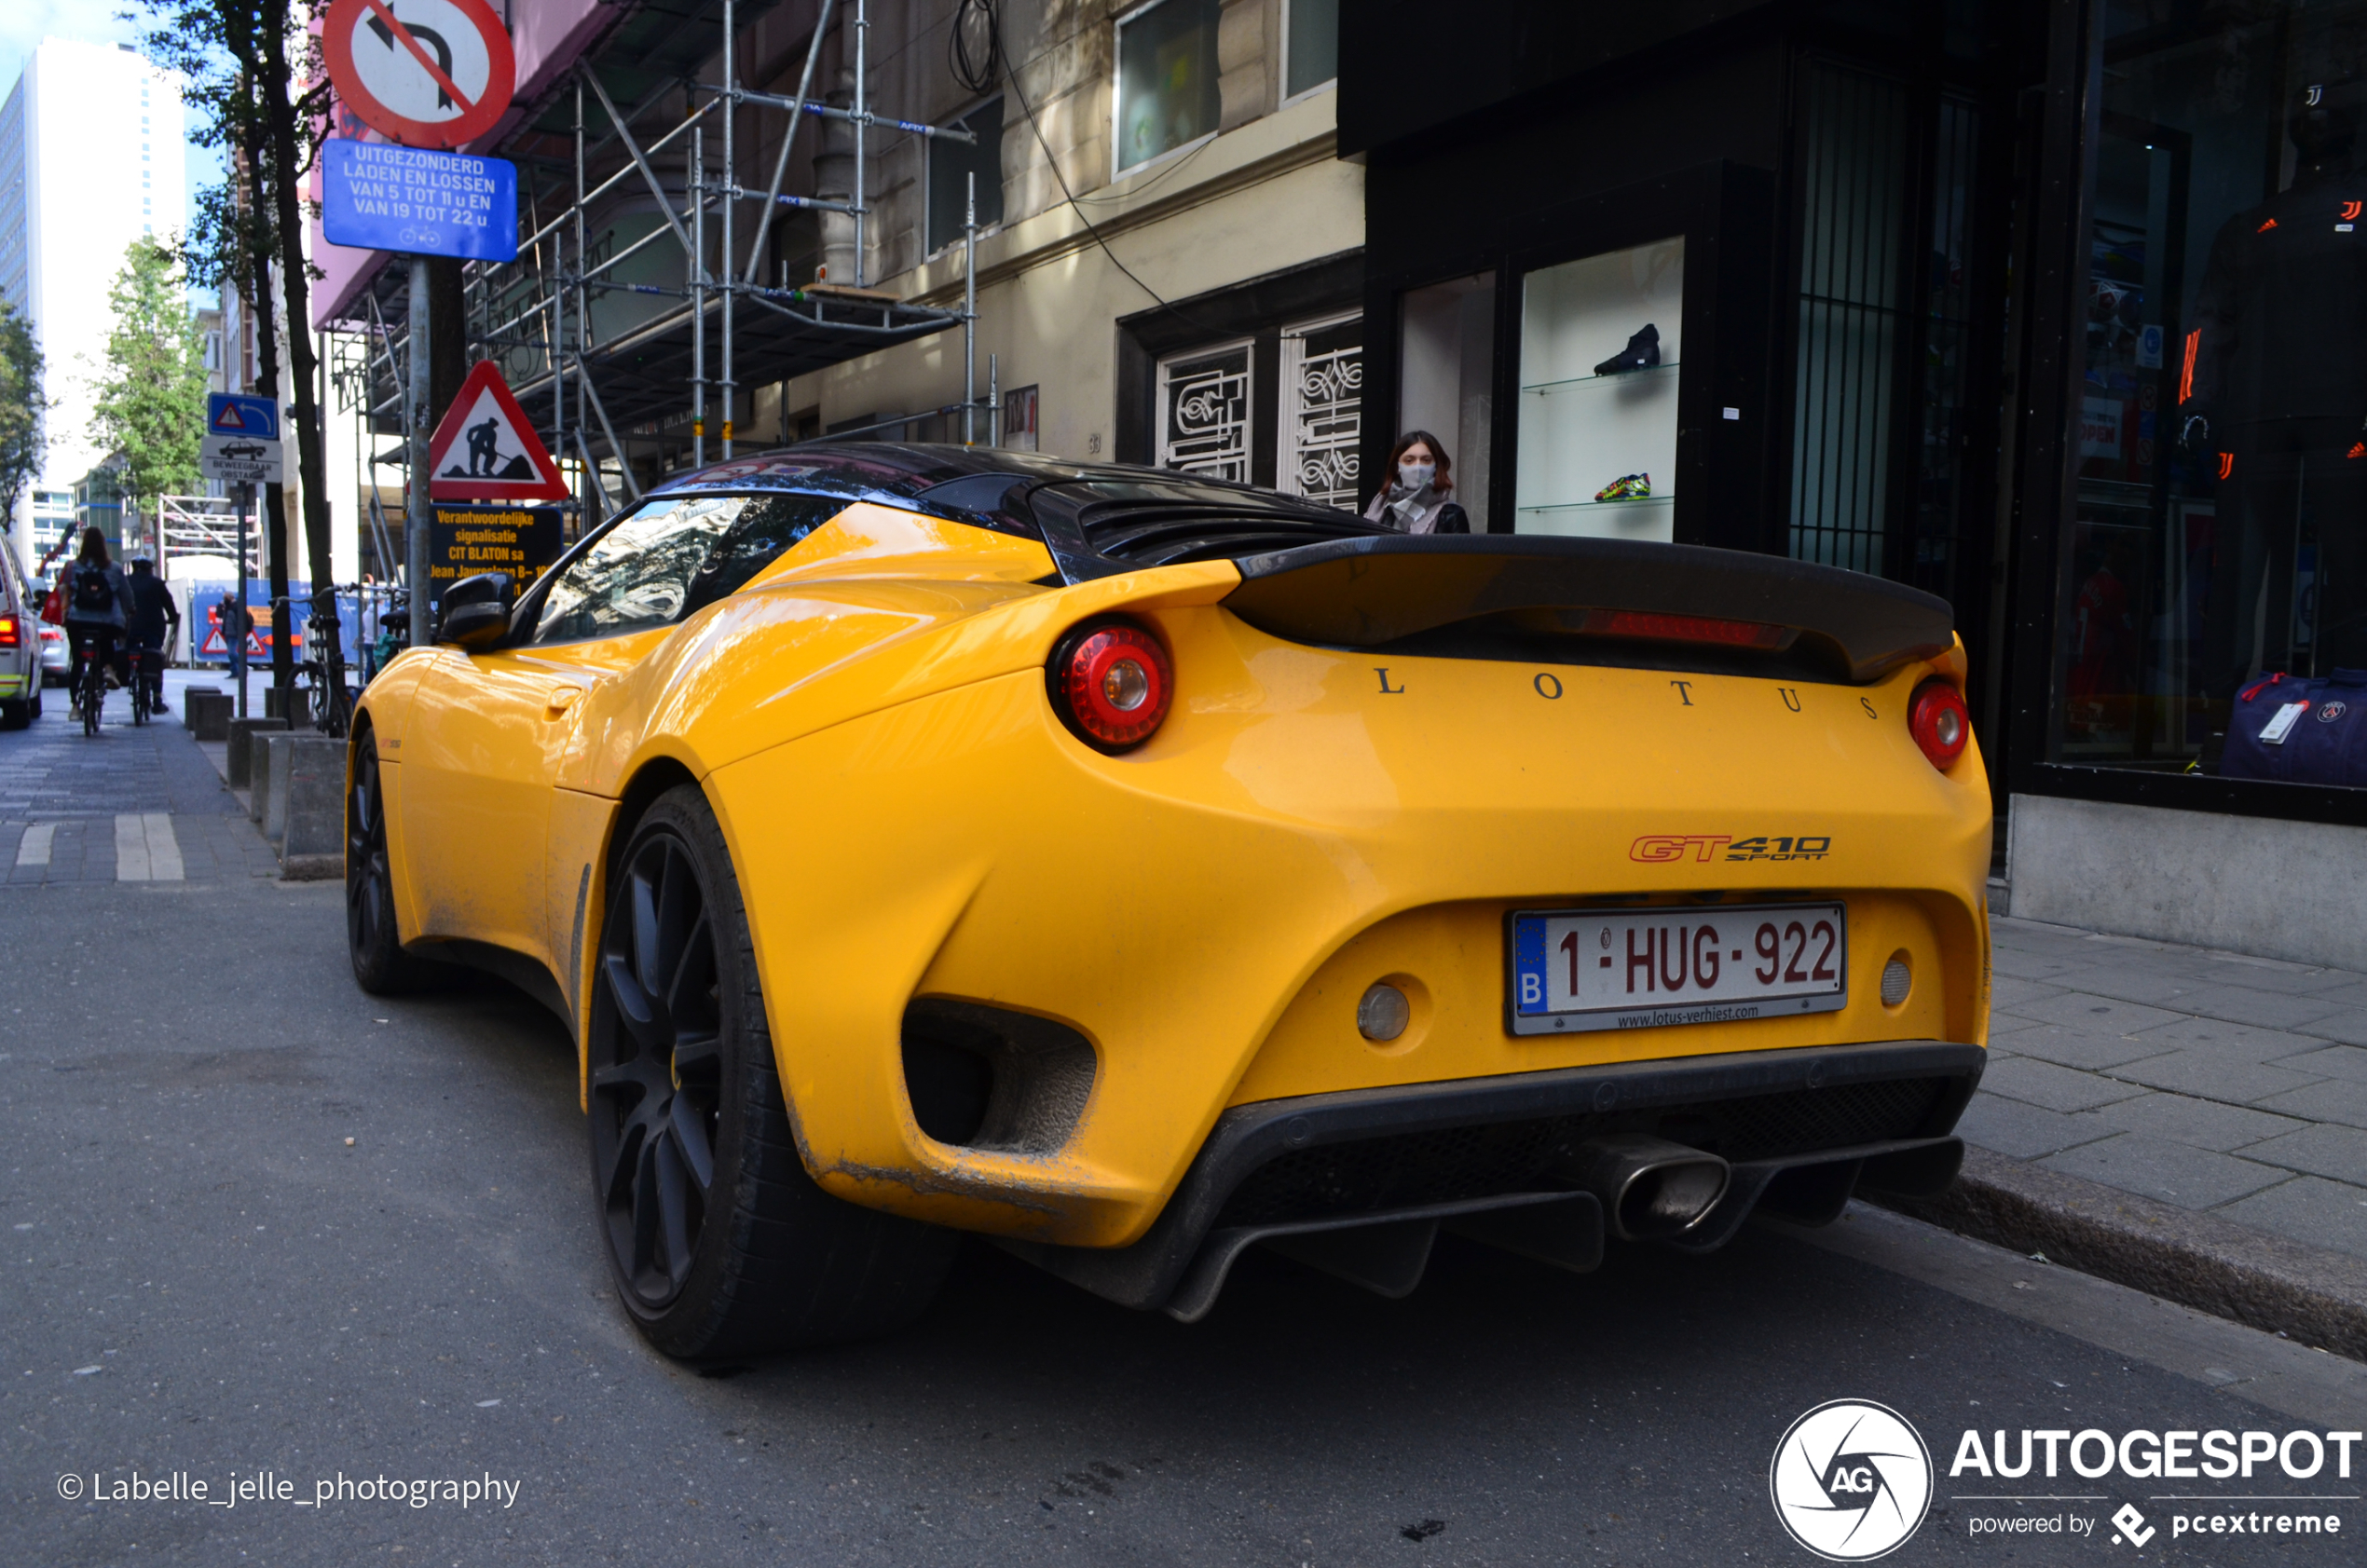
400,495 -> 845,984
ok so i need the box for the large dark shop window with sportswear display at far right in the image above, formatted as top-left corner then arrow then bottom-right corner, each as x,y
2050,0 -> 2367,783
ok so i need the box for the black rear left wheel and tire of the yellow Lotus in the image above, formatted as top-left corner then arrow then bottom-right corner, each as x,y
587,785 -> 959,1365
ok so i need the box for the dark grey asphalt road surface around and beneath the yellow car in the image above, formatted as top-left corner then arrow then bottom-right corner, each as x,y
0,878 -> 2367,1565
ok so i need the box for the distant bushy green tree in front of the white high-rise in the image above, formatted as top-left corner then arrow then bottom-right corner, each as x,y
90,239 -> 206,529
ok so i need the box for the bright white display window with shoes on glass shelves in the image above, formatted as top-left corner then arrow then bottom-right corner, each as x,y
1514,239 -> 1685,541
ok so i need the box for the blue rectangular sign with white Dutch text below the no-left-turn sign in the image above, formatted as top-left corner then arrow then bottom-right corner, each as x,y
320,137 -> 518,260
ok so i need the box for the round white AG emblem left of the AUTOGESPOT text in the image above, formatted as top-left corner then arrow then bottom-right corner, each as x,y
1768,1400 -> 1932,1563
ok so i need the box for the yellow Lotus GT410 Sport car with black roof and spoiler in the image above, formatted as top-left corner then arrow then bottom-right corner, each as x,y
346,443 -> 1991,1362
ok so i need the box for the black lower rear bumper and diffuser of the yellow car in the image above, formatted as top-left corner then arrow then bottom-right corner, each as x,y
1001,1041 -> 1989,1322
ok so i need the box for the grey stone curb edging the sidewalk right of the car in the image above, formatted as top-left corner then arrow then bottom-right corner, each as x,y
1880,1145 -> 2367,1362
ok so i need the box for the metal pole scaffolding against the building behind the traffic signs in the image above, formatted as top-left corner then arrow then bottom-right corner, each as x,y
352,0 -> 999,523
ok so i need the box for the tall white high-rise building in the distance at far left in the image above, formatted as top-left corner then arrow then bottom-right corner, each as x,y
0,38 -> 189,567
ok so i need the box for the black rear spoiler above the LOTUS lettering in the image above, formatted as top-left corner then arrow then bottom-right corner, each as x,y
1224,535 -> 1955,684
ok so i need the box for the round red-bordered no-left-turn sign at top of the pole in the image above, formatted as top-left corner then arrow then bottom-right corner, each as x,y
322,0 -> 518,146
